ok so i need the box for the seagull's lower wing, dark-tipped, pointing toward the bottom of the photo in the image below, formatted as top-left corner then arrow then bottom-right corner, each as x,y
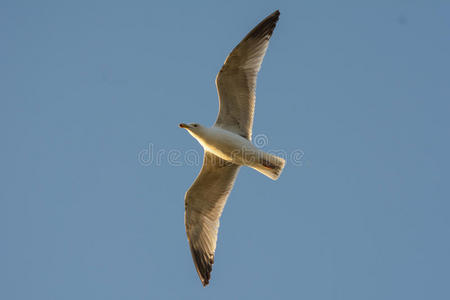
184,152 -> 239,286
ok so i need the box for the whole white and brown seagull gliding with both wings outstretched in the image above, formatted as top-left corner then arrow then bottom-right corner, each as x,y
179,10 -> 285,286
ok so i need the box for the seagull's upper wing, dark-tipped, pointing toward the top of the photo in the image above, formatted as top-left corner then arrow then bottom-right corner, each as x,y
215,10 -> 280,139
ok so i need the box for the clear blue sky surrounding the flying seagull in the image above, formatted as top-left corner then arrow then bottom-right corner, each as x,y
0,0 -> 450,300
